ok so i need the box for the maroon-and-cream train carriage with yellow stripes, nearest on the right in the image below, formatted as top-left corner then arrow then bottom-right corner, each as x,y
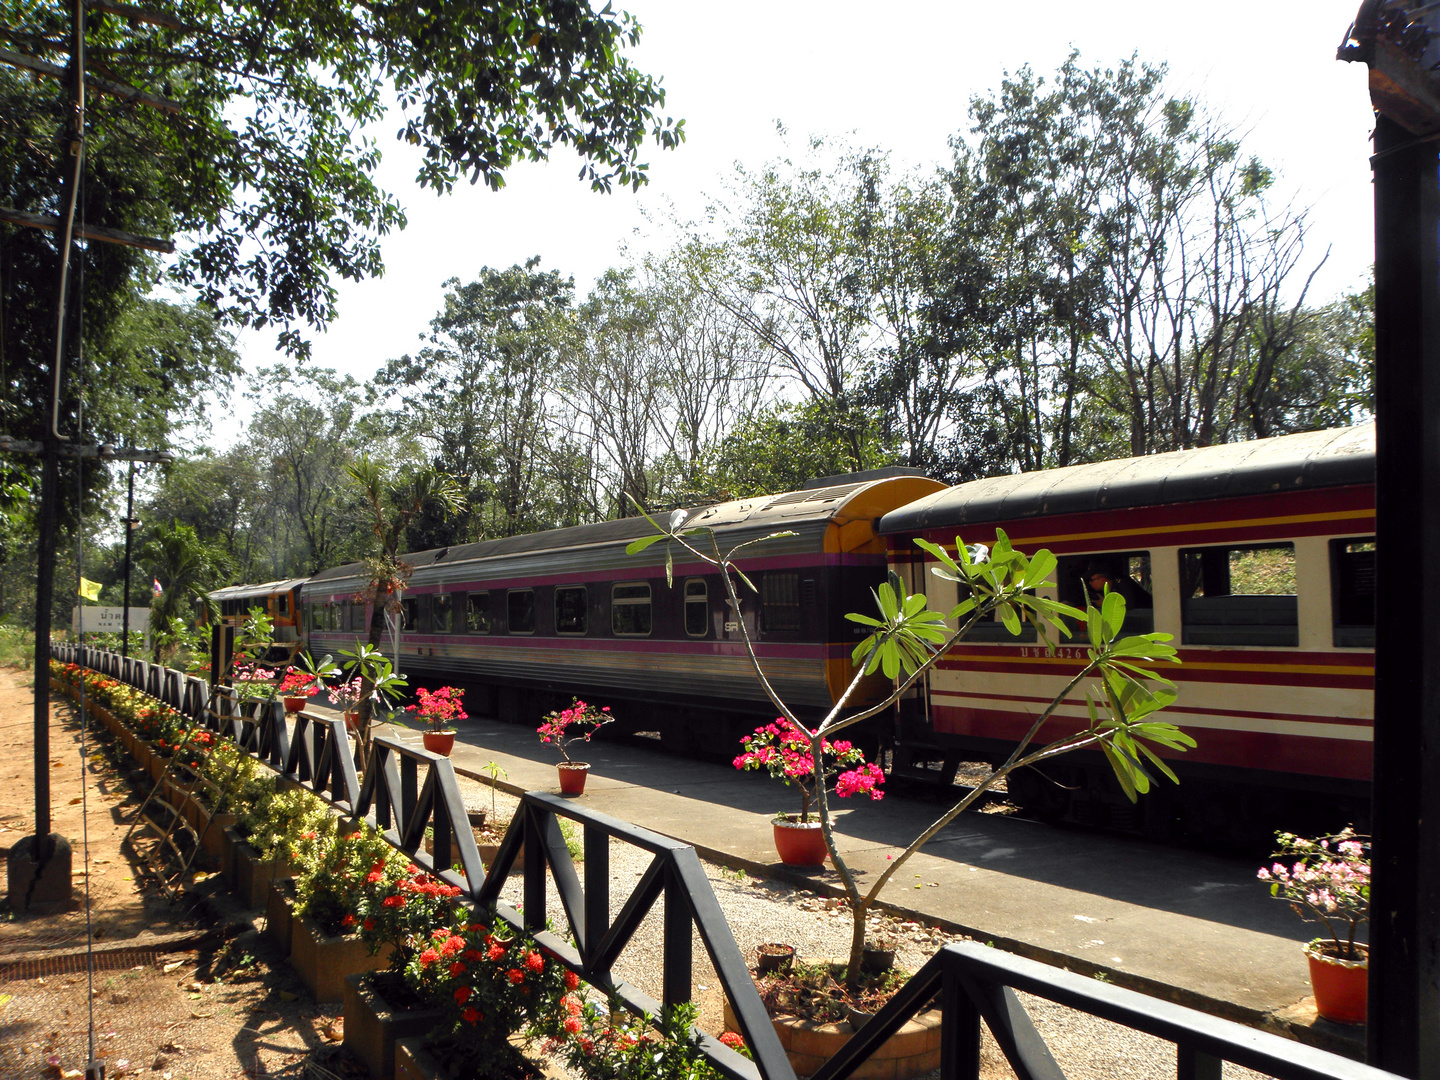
880,425 -> 1375,837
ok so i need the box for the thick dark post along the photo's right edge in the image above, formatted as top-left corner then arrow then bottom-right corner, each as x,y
1338,0 -> 1440,1080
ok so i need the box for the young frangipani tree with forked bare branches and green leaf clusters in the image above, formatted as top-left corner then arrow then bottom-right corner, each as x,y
625,508 -> 1195,992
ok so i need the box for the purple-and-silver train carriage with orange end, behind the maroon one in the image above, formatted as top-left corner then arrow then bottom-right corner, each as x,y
302,471 -> 942,755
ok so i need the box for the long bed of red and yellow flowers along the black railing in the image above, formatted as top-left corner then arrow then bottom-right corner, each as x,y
52,662 -> 743,1080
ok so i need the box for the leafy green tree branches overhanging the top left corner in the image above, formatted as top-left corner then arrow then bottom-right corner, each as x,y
0,0 -> 684,364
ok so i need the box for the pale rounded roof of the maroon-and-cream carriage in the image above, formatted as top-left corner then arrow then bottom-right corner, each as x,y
880,423 -> 1375,536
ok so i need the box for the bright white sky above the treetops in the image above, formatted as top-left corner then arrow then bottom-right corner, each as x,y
227,0 -> 1374,397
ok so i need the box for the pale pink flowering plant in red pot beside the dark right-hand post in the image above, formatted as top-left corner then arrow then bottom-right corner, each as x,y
1259,827 -> 1369,1024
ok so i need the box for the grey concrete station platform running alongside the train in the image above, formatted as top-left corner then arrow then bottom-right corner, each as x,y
351,719 -> 1336,1043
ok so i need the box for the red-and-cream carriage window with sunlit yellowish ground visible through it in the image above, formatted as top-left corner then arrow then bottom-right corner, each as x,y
1179,544 -> 1300,645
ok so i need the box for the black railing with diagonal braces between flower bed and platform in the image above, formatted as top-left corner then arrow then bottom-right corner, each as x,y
52,645 -> 1400,1080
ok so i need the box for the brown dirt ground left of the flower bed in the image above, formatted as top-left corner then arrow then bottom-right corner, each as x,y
0,668 -> 364,1080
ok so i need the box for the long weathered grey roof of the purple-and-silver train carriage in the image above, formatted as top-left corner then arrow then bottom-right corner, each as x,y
310,475 -> 940,585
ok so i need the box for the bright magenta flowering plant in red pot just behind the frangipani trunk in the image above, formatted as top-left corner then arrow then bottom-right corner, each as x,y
734,716 -> 884,867
